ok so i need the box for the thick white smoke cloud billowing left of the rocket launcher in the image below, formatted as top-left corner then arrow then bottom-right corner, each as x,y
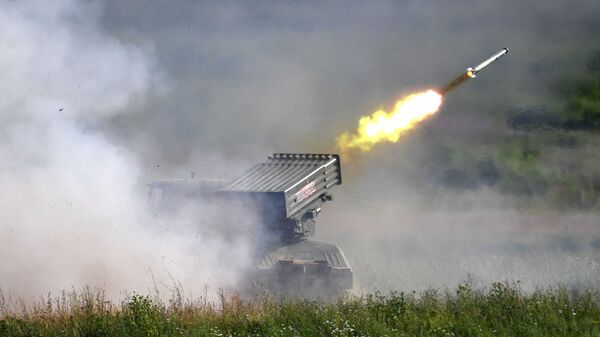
0,0 -> 255,298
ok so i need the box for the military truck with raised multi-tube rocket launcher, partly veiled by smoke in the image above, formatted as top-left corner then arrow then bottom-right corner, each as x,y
150,153 -> 353,299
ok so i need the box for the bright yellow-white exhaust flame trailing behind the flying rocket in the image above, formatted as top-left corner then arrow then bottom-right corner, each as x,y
336,90 -> 442,153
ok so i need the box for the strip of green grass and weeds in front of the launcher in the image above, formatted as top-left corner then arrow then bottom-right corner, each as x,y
0,283 -> 600,337
